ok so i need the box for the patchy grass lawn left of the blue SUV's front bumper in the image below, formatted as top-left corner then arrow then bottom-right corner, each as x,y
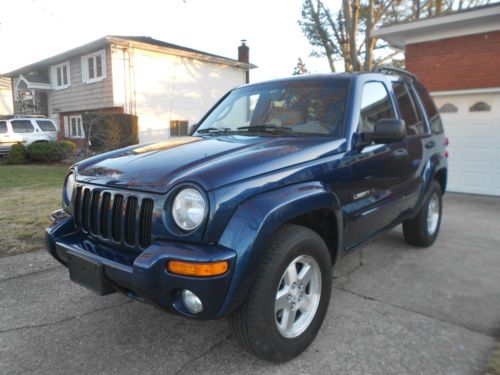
0,164 -> 69,257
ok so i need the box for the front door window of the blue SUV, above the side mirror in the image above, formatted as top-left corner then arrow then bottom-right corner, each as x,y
359,82 -> 396,133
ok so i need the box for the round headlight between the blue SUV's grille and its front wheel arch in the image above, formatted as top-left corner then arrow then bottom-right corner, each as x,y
172,188 -> 205,230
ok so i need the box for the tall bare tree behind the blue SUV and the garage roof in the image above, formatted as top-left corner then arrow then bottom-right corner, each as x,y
299,0 -> 489,72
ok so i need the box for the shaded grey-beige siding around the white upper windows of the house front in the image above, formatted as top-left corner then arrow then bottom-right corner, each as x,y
49,46 -> 113,117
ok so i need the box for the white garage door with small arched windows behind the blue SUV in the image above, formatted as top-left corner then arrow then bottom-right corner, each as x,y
435,94 -> 500,196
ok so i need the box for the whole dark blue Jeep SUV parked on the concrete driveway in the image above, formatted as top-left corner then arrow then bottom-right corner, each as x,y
46,68 -> 447,362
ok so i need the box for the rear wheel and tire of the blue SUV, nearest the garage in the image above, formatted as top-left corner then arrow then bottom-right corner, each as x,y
403,180 -> 443,247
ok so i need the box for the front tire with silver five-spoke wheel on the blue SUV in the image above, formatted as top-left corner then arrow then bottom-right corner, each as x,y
230,225 -> 332,362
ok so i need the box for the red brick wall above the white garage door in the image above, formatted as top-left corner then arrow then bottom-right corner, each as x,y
405,31 -> 500,91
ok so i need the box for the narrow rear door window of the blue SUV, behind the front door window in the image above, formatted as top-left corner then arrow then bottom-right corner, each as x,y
392,82 -> 425,135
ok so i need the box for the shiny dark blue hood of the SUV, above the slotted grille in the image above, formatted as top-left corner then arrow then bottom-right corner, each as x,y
75,135 -> 345,193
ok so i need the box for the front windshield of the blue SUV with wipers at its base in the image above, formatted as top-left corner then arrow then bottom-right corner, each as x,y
195,79 -> 349,137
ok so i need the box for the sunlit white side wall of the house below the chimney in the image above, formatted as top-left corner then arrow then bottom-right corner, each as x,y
112,47 -> 246,142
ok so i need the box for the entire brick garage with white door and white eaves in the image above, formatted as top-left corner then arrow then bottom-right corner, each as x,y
375,3 -> 500,196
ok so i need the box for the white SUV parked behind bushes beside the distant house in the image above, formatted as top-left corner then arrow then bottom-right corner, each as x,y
0,116 -> 57,155
